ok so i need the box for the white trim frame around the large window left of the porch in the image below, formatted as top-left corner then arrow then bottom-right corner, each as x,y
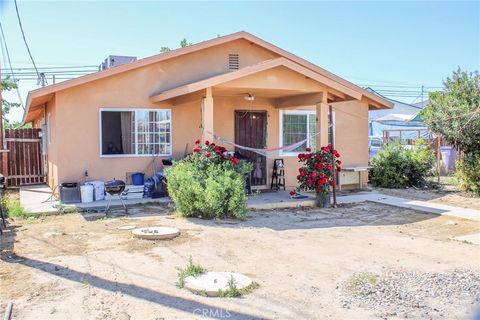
98,107 -> 173,158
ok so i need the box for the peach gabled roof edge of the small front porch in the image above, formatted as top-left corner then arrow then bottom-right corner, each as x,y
150,58 -> 362,102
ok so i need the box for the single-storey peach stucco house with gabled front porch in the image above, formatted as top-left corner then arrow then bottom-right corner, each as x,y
24,32 -> 392,187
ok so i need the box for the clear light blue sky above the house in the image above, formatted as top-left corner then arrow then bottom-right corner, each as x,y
0,0 -> 480,119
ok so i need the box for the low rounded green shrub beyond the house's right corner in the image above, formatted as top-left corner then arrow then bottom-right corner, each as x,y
370,143 -> 435,188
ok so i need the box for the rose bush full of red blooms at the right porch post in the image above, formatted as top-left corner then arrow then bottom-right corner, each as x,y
292,145 -> 342,207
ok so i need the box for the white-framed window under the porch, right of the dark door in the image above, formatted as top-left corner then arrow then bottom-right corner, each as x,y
279,110 -> 335,156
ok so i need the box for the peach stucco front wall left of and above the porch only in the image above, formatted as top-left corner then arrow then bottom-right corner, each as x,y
36,39 -> 278,188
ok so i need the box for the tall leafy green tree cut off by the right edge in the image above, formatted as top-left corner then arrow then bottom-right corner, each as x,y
422,69 -> 480,154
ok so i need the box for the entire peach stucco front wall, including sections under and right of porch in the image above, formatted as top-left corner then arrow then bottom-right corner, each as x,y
30,40 -> 368,188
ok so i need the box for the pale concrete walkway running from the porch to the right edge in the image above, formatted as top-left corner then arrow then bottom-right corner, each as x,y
337,192 -> 480,221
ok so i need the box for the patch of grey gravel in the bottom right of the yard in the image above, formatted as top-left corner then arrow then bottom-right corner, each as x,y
342,269 -> 480,319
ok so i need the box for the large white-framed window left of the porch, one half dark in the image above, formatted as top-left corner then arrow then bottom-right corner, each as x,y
100,108 -> 172,157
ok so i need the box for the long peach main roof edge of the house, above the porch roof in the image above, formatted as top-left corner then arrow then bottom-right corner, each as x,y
24,31 -> 393,120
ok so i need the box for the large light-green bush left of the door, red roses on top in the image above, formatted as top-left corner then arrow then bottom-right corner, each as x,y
166,141 -> 251,219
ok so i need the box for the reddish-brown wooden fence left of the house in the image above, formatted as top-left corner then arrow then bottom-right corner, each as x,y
2,129 -> 46,187
